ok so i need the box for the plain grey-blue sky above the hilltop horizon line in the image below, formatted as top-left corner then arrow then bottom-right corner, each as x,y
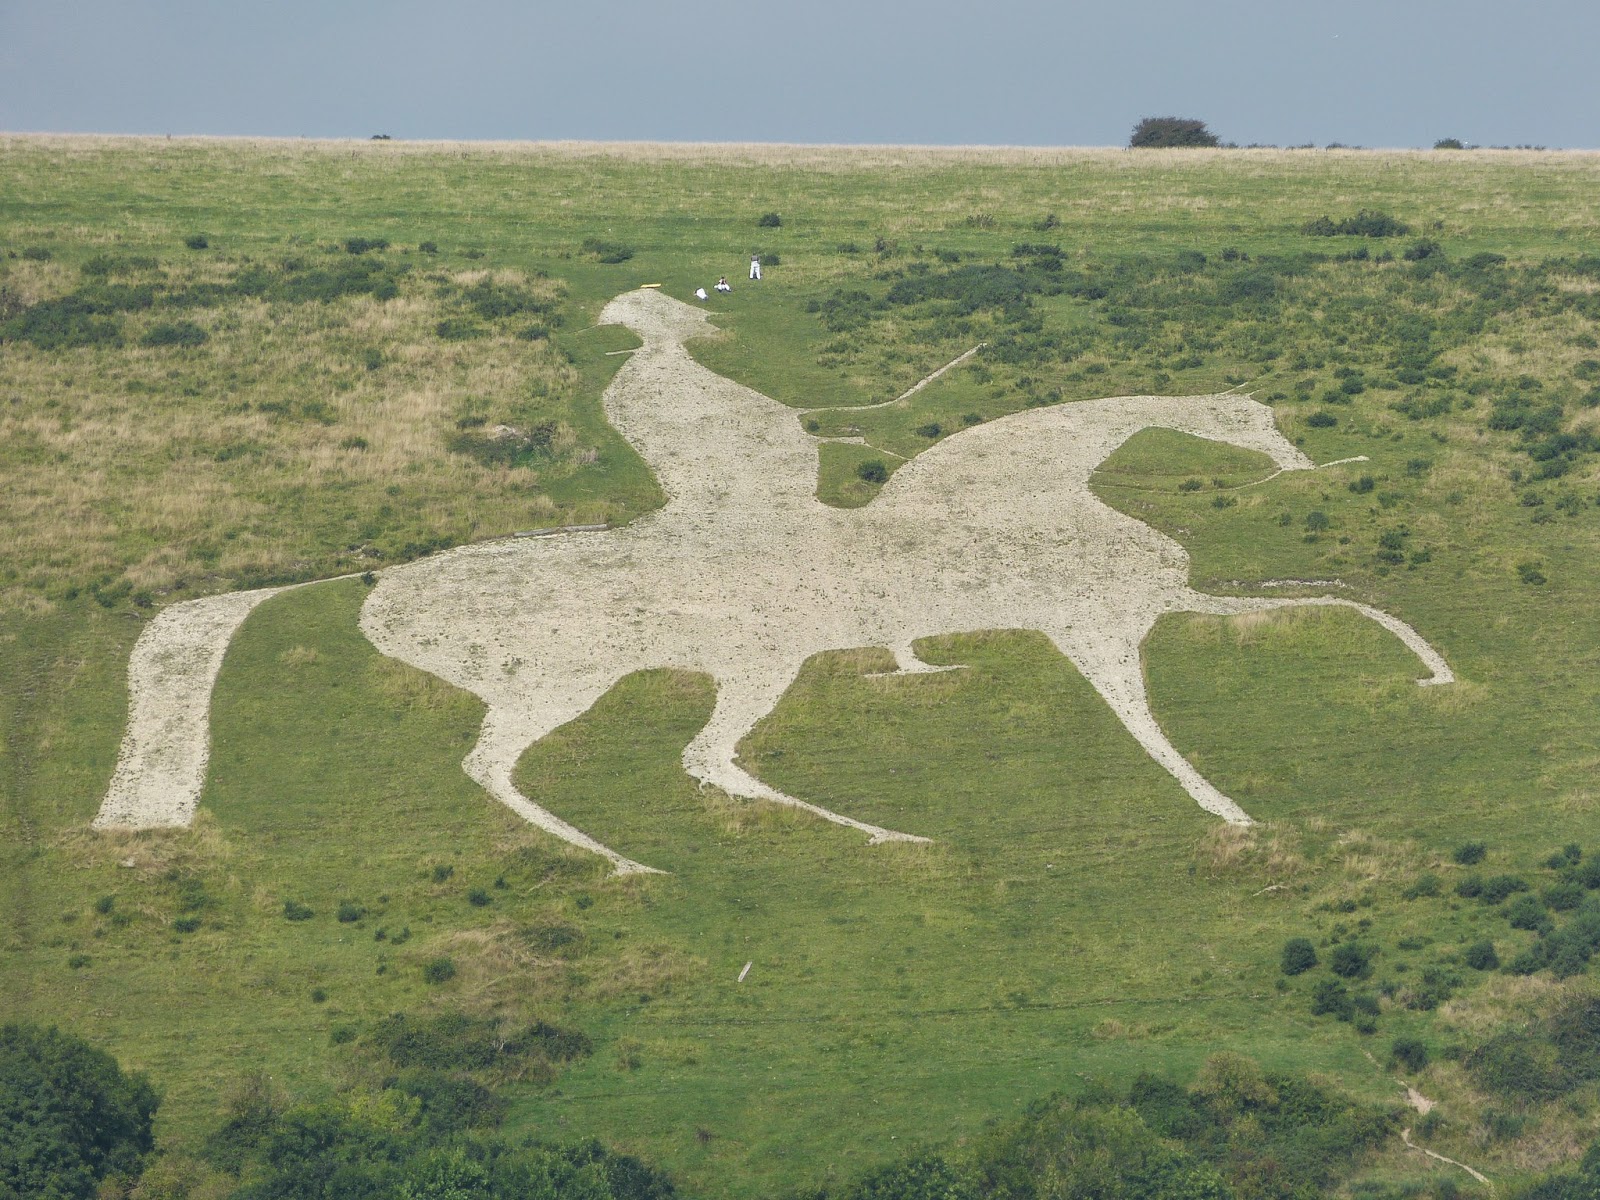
0,0 -> 1600,147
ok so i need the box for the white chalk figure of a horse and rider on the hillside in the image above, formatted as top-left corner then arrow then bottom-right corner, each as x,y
98,291 -> 1453,874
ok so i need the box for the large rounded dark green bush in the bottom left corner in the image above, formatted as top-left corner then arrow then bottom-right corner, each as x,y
0,1024 -> 158,1200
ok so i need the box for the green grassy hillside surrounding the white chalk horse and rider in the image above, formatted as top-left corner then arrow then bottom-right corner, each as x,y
0,138 -> 1600,1197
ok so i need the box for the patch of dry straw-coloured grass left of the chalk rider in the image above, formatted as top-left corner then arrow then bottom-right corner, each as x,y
0,262 -> 582,594
